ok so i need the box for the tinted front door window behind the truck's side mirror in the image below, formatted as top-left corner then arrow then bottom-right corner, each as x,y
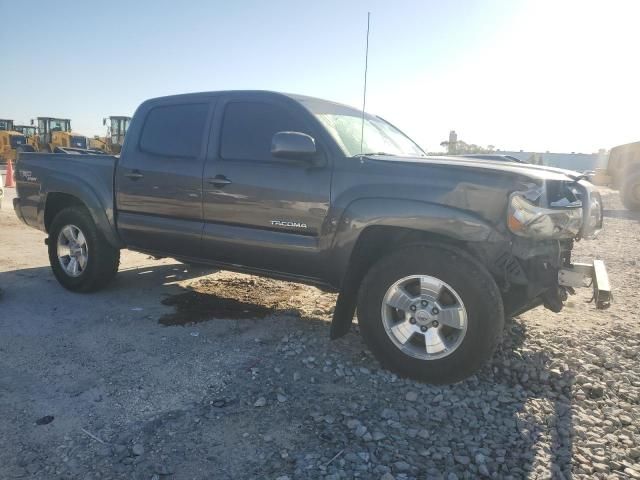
220,102 -> 309,160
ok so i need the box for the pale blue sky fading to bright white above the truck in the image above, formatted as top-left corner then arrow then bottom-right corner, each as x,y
0,0 -> 640,153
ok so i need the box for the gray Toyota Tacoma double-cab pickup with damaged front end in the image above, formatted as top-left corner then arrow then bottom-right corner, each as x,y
14,91 -> 611,383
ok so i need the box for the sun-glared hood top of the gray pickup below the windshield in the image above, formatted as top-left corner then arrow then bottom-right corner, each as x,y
367,155 -> 584,181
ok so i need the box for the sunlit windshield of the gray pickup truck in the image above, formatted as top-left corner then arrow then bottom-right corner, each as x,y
315,113 -> 424,157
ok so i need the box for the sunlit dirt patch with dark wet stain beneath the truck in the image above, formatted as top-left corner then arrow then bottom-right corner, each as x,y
158,274 -> 335,326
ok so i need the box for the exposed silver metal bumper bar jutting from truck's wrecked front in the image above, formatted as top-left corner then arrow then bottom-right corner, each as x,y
558,260 -> 613,310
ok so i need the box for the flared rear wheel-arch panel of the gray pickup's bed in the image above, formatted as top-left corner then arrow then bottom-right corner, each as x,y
38,172 -> 124,248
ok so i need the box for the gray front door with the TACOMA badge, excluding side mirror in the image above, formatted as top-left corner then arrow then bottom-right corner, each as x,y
203,97 -> 331,276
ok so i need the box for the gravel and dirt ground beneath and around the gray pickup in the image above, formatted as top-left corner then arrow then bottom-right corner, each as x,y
0,187 -> 640,480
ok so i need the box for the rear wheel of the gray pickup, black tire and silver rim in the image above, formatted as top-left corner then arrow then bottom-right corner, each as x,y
48,206 -> 120,292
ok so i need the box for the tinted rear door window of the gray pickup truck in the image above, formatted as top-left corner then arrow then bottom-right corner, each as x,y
140,103 -> 209,158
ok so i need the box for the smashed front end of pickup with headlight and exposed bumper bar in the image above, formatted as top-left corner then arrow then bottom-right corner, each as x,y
476,179 -> 613,316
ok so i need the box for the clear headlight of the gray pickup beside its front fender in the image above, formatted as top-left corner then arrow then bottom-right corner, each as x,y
507,193 -> 582,239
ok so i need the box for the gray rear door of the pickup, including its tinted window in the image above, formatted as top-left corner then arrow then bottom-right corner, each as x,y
116,98 -> 213,257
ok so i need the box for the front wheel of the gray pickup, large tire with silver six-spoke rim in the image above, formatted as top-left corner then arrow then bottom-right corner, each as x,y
358,245 -> 504,384
